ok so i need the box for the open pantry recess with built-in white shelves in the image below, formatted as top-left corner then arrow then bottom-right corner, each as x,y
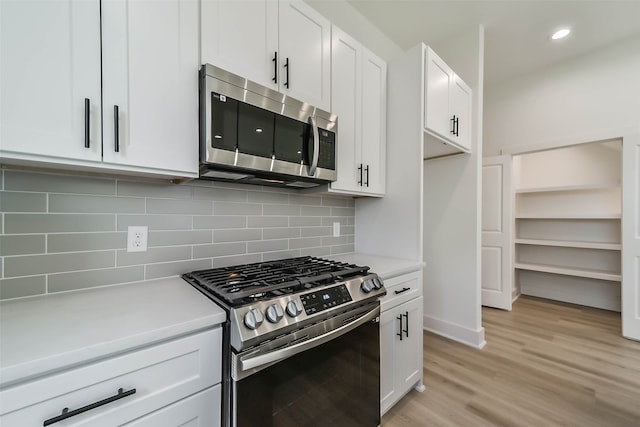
513,141 -> 622,311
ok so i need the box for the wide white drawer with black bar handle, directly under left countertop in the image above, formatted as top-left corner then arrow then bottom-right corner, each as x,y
0,328 -> 222,427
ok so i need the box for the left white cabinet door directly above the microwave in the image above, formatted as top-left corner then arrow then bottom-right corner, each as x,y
201,0 -> 278,90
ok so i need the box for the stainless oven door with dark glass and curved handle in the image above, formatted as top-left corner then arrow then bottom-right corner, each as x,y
232,301 -> 380,427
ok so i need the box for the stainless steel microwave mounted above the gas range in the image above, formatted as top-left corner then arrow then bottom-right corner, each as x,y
200,64 -> 338,188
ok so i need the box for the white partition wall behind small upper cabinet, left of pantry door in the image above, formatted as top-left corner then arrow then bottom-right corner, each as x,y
423,28 -> 485,347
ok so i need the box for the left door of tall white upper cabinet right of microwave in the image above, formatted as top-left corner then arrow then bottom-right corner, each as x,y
331,26 -> 362,191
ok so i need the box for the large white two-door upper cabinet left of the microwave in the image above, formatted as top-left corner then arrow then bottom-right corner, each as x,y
0,0 -> 199,177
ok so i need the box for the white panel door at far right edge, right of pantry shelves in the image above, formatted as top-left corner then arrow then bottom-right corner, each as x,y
622,134 -> 640,340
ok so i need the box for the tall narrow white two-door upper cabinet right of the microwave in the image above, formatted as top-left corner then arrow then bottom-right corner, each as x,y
330,26 -> 387,196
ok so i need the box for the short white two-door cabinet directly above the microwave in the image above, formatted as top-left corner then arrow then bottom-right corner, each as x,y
201,0 -> 331,111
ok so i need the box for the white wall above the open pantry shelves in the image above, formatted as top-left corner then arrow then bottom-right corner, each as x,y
484,33 -> 640,156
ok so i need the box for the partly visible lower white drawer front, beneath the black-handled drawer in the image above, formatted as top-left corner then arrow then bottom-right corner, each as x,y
124,384 -> 222,427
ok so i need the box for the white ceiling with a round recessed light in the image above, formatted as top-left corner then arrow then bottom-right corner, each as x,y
347,0 -> 640,85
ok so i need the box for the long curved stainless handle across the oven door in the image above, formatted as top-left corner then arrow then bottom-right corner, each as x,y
240,306 -> 380,371
